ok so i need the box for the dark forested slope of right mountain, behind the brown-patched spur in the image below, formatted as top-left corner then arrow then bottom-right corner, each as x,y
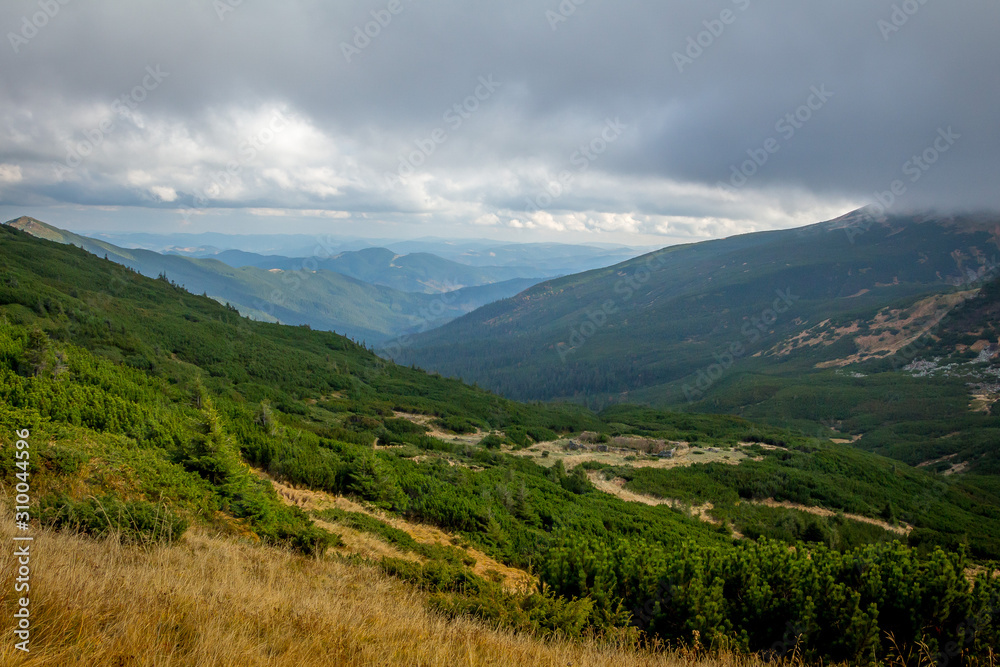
398,213 -> 998,404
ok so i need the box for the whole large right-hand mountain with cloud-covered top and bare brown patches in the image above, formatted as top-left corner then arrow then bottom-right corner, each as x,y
392,211 -> 1000,473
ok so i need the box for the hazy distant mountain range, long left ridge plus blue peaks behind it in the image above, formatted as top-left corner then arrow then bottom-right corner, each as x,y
6,217 -> 536,345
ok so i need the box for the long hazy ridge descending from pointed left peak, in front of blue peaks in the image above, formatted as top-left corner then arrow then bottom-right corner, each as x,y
7,217 -> 533,344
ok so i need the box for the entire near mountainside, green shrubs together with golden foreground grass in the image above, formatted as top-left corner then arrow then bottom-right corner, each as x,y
0,219 -> 1000,665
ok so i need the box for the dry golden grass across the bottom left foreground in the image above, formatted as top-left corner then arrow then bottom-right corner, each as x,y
0,508 -> 804,667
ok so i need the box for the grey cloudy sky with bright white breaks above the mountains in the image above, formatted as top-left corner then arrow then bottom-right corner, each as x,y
0,0 -> 1000,244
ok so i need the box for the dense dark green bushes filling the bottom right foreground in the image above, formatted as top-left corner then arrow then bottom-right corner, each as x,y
541,536 -> 1000,662
